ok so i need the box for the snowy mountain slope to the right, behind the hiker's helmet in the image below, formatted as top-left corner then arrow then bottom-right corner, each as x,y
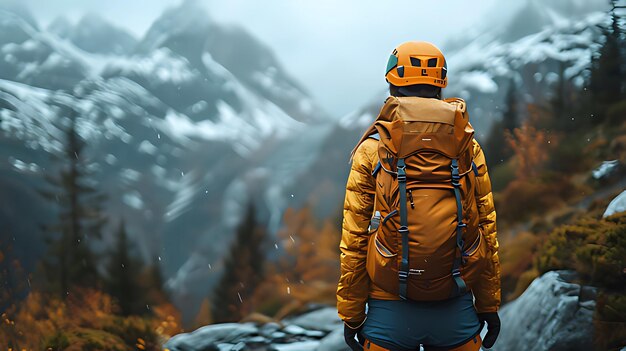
340,0 -> 608,139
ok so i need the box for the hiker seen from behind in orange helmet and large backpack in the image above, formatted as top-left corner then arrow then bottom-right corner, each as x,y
337,42 -> 500,351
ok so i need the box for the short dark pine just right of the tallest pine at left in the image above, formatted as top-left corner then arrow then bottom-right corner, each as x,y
107,221 -> 146,316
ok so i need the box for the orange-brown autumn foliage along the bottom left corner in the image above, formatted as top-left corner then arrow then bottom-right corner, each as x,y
0,288 -> 181,351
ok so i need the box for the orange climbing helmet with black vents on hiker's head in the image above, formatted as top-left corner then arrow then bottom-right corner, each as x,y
385,41 -> 448,88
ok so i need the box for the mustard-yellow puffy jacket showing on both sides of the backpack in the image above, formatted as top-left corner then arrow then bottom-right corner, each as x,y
337,125 -> 500,327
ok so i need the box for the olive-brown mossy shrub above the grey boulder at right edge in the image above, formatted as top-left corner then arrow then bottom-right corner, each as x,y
532,212 -> 626,350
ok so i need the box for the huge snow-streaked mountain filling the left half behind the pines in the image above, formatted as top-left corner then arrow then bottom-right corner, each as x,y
0,1 -> 331,324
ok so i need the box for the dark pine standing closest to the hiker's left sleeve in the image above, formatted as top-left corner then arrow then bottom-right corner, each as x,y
211,204 -> 266,323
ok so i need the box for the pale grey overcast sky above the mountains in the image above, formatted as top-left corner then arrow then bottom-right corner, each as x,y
20,0 -> 496,116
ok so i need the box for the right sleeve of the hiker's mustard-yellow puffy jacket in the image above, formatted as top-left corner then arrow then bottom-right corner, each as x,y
473,140 -> 500,313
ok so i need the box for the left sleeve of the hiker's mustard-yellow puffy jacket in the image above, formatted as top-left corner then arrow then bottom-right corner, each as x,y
337,139 -> 377,328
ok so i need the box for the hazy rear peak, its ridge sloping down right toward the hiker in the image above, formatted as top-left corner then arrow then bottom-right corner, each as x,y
137,0 -> 326,121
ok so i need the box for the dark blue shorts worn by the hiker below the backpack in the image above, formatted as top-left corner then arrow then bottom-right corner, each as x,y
363,293 -> 481,351
